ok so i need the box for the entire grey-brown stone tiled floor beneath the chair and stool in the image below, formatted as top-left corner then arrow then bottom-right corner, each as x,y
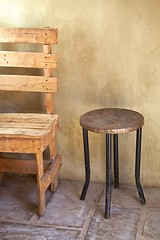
0,175 -> 160,240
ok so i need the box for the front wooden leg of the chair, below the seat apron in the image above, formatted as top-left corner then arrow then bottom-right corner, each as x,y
36,153 -> 46,216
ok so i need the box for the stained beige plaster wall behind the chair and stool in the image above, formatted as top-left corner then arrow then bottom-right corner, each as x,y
0,0 -> 160,186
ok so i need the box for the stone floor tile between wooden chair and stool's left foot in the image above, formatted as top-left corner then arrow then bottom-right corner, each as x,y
34,181 -> 102,228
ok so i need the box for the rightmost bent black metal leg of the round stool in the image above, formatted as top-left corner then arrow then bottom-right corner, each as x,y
135,128 -> 146,204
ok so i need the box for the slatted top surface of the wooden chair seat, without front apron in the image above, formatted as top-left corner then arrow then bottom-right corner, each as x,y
0,113 -> 58,139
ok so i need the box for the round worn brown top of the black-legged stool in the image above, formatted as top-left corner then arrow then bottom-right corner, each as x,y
80,108 -> 144,134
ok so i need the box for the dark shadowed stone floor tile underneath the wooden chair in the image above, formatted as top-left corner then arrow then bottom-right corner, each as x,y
0,175 -> 51,222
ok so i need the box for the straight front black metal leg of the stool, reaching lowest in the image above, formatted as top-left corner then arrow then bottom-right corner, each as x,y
105,134 -> 112,218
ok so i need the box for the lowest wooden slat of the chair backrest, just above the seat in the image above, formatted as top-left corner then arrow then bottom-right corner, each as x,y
0,75 -> 58,92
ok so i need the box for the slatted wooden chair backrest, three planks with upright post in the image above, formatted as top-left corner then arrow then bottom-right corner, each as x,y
0,28 -> 58,114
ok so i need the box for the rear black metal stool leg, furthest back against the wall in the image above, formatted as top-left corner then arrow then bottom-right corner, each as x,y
113,134 -> 119,188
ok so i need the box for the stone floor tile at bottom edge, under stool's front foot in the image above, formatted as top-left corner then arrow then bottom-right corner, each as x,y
85,207 -> 141,240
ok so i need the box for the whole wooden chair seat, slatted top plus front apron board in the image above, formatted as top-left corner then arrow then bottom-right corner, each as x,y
0,113 -> 58,153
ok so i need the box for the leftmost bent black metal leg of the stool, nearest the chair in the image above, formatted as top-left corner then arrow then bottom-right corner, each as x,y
80,128 -> 90,200
